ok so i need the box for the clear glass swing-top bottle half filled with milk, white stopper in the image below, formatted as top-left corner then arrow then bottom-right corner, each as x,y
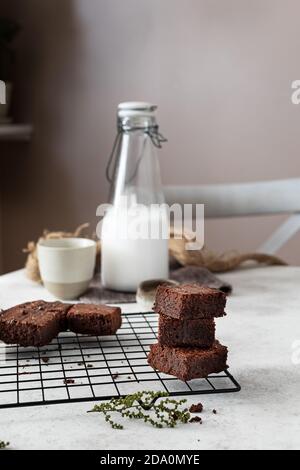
101,102 -> 169,292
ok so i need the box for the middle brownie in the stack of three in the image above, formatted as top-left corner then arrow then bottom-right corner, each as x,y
158,315 -> 216,348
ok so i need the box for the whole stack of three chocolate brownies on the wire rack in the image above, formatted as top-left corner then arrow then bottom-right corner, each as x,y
148,284 -> 227,381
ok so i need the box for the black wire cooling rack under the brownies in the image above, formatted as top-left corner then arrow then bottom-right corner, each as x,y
0,312 -> 240,408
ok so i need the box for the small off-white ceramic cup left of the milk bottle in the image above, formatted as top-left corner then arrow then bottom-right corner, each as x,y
38,238 -> 96,300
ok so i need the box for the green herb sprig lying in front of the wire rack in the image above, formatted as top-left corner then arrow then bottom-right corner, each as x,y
88,391 -> 190,429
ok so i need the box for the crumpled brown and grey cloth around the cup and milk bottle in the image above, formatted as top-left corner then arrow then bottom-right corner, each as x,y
24,224 -> 286,303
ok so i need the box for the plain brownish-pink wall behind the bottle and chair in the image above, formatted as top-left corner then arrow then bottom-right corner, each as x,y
0,0 -> 300,271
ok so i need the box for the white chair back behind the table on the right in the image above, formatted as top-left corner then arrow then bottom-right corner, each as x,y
164,178 -> 300,254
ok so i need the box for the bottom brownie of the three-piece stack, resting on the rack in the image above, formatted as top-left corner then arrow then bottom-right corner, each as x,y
148,341 -> 227,381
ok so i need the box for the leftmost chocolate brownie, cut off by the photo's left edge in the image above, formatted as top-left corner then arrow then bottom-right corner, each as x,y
0,300 -> 71,346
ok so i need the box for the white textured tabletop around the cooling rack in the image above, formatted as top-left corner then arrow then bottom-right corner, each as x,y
0,267 -> 300,450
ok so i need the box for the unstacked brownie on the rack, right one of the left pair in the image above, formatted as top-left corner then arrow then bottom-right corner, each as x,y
67,304 -> 122,336
